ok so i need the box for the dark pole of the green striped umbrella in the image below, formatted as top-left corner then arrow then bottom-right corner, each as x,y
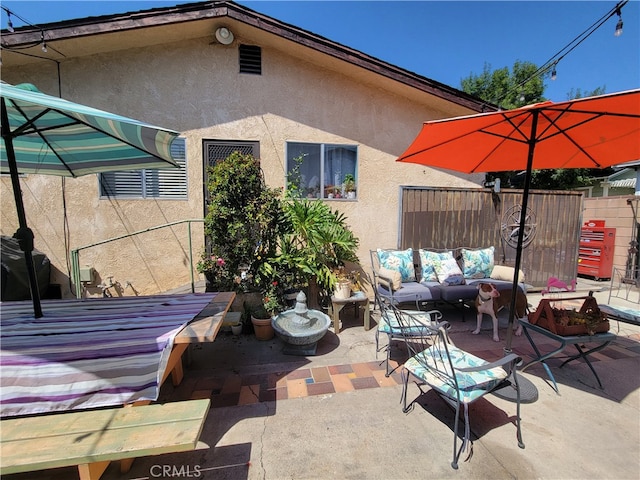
1,98 -> 42,318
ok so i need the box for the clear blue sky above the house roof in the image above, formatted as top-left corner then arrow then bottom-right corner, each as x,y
1,0 -> 640,101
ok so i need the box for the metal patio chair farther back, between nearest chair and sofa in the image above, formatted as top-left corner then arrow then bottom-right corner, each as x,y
375,292 -> 442,377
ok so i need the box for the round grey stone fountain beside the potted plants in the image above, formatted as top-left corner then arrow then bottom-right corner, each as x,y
271,292 -> 331,355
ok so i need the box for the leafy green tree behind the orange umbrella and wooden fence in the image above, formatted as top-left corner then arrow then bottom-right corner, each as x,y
460,61 -> 613,190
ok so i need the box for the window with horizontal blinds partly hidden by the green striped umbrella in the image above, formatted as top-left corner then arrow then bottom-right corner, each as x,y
98,138 -> 188,200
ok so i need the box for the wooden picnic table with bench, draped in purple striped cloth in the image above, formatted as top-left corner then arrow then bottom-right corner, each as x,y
0,292 -> 235,480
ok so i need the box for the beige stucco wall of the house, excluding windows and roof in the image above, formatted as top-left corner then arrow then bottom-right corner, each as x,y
0,31 -> 482,295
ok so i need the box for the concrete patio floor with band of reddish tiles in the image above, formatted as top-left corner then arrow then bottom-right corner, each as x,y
6,279 -> 640,480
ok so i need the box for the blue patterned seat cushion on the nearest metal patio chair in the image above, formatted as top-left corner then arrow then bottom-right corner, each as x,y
404,345 -> 507,403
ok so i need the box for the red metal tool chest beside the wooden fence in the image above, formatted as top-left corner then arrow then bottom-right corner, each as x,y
578,220 -> 616,280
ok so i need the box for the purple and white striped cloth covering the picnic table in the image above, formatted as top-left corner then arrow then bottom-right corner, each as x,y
0,293 -> 216,417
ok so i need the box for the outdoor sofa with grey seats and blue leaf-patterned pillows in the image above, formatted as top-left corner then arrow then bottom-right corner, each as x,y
370,246 -> 526,309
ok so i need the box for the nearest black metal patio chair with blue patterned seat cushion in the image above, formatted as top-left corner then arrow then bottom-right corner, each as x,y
391,306 -> 524,469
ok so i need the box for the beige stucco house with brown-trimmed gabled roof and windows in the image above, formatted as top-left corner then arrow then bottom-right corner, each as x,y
0,2 -> 493,296
